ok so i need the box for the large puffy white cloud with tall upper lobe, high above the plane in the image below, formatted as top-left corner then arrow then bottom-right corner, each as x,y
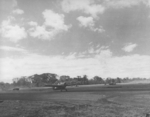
28,10 -> 70,40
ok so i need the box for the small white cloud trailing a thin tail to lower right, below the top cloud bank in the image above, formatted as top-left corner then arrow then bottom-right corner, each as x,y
77,16 -> 105,33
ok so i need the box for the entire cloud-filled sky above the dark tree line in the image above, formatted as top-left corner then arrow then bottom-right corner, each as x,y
0,0 -> 150,82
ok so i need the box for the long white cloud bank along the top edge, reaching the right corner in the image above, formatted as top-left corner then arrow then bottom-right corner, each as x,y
61,0 -> 150,18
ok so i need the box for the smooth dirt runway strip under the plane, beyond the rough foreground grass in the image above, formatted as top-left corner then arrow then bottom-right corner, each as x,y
0,84 -> 150,101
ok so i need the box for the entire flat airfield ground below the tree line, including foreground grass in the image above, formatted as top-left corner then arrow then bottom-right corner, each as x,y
0,82 -> 150,117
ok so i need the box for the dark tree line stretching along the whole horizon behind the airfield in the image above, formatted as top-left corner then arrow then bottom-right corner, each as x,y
0,73 -> 148,90
